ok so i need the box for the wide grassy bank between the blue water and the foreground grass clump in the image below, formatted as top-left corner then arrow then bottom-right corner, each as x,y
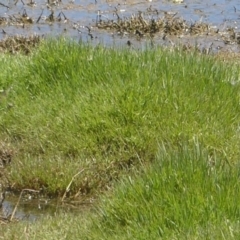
0,40 -> 240,196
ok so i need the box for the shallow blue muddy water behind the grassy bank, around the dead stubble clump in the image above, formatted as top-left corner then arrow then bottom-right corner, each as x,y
0,0 -> 240,51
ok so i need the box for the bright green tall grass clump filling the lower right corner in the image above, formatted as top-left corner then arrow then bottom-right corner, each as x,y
90,145 -> 240,239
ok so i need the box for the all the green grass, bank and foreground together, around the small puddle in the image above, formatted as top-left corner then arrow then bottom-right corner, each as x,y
0,39 -> 240,239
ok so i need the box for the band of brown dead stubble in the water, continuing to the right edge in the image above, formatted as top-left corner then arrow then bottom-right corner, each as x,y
96,8 -> 240,45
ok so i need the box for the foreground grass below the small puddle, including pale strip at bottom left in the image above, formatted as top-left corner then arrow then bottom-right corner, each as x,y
0,143 -> 240,240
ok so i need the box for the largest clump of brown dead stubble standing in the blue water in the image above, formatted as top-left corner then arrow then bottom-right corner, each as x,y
97,11 -> 213,37
